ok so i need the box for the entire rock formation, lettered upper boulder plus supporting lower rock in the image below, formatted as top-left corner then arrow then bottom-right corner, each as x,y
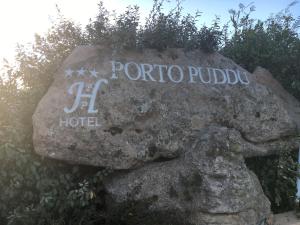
33,46 -> 300,225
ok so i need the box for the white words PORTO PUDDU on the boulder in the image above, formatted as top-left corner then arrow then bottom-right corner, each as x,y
111,61 -> 250,85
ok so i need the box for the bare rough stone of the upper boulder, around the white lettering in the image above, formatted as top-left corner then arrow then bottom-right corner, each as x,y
33,46 -> 300,169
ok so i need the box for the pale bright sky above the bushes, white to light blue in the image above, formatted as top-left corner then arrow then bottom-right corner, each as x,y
0,0 -> 300,66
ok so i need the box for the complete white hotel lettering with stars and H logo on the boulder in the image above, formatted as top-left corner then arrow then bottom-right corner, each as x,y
59,60 -> 250,128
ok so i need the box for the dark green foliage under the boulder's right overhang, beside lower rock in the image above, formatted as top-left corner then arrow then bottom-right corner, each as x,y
246,149 -> 298,213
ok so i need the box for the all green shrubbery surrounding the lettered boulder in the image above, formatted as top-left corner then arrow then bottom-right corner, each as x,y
0,0 -> 300,225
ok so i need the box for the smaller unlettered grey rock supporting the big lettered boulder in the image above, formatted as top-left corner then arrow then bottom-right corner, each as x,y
105,127 -> 271,225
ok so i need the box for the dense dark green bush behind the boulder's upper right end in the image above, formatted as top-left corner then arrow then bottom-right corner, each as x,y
221,2 -> 300,99
